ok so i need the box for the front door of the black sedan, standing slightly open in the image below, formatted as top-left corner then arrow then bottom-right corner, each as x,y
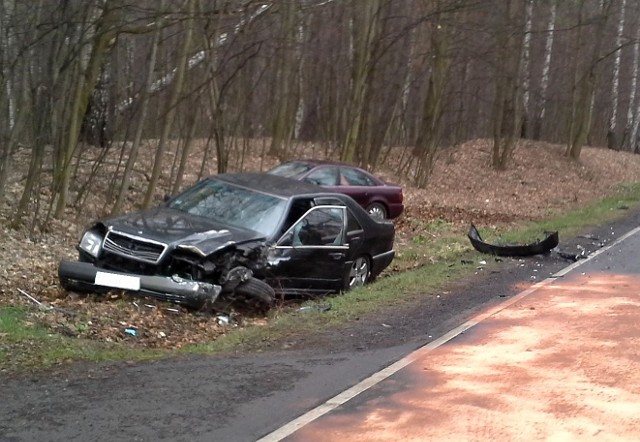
268,205 -> 349,293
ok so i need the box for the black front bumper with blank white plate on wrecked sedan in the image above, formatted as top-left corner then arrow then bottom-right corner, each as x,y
58,261 -> 222,306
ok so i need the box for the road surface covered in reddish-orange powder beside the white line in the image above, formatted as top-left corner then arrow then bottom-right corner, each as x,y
285,272 -> 640,441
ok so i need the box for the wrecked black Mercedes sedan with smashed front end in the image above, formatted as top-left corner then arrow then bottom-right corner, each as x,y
58,173 -> 395,306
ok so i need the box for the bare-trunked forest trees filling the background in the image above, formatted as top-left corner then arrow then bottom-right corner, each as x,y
0,0 -> 640,230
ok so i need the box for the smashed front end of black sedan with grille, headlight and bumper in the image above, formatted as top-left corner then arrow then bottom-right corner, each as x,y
58,224 -> 267,307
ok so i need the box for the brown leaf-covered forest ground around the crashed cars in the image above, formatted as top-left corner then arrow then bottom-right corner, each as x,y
0,140 -> 640,347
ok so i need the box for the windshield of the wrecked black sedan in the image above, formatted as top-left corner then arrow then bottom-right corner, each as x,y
168,180 -> 287,236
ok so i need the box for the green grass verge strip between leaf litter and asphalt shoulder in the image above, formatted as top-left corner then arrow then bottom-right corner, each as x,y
0,184 -> 640,372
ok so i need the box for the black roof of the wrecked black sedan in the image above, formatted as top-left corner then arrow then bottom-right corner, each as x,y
210,172 -> 327,198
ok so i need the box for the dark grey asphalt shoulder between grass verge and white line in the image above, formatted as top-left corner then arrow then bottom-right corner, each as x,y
0,208 -> 640,441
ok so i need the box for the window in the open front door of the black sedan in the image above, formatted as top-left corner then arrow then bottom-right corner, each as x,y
278,207 -> 345,247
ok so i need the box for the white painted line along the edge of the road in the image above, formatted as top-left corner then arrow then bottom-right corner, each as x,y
257,227 -> 640,442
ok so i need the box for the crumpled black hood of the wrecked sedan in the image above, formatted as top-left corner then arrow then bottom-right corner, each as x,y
101,207 -> 264,255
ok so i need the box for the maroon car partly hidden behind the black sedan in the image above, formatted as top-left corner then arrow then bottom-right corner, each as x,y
268,160 -> 404,219
